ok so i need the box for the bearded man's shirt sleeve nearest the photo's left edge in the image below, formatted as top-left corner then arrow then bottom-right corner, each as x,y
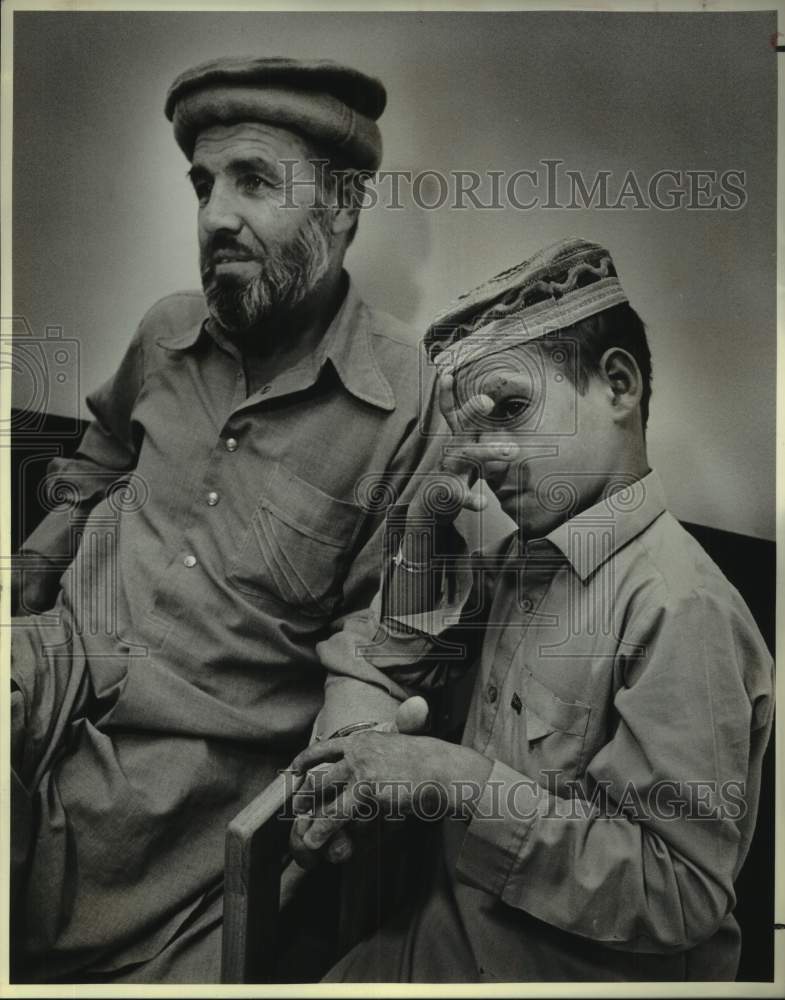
20,327 -> 144,570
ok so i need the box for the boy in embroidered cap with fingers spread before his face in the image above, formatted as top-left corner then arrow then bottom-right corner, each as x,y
293,240 -> 773,982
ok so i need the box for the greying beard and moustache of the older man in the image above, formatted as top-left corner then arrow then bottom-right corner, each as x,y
201,210 -> 332,335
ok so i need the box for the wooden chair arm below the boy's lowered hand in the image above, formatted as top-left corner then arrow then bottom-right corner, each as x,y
221,772 -> 305,983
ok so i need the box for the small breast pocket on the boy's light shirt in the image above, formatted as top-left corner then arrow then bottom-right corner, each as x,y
519,666 -> 591,788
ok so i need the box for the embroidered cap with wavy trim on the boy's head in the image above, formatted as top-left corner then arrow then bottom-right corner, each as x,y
425,237 -> 628,374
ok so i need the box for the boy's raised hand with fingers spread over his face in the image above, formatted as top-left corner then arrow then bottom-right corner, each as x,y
409,375 -> 518,524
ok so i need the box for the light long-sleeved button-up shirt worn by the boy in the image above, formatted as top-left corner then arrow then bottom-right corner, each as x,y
356,472 -> 773,980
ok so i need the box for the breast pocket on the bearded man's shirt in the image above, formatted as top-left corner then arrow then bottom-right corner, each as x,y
227,462 -> 361,617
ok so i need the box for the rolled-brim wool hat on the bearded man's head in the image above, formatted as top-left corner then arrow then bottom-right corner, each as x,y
164,57 -> 387,170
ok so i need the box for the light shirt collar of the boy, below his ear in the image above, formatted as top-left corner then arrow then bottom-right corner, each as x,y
527,471 -> 667,581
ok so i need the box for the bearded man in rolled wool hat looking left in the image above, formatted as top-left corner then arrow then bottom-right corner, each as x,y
12,59 -> 438,982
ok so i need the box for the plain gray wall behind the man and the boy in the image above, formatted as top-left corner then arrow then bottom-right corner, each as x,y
13,12 -> 777,538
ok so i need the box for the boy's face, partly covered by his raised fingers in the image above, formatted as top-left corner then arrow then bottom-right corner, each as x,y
455,340 -> 621,537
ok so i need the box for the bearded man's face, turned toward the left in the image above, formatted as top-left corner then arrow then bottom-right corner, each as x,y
189,122 -> 334,334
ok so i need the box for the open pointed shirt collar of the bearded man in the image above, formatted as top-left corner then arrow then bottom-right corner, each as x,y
157,272 -> 395,410
